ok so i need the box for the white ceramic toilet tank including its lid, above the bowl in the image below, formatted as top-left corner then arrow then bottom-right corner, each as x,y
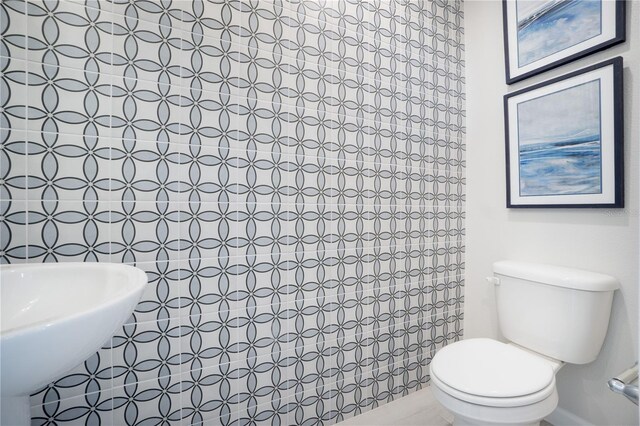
493,261 -> 619,364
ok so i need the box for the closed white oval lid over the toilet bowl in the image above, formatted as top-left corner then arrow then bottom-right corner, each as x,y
431,339 -> 555,398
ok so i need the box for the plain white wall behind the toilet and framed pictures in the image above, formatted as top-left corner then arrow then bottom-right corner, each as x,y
465,1 -> 640,425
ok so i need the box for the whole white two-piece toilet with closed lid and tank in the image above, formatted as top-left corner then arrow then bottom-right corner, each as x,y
430,261 -> 619,426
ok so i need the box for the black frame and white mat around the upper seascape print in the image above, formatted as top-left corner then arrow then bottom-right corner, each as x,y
502,0 -> 626,84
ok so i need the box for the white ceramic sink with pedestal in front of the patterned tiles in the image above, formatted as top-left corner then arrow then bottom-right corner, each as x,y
0,263 -> 147,426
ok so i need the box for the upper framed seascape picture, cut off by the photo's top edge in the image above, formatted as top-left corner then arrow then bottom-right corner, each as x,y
502,0 -> 625,84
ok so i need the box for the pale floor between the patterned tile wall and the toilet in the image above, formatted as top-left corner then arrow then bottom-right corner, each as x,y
340,387 -> 553,426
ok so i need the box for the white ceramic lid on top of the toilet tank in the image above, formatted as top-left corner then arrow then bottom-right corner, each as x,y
493,260 -> 620,291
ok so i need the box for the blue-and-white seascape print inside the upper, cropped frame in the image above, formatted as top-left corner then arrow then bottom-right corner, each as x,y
516,0 -> 602,67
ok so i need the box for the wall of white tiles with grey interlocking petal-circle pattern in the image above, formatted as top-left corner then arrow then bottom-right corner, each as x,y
0,0 -> 465,425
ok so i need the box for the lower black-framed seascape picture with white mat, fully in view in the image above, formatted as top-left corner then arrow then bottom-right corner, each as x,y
504,57 -> 624,207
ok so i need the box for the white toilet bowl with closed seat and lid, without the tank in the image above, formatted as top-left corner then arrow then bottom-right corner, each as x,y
430,339 -> 562,426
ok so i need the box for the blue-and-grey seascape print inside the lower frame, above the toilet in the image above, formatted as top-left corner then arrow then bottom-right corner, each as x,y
517,80 -> 602,197
